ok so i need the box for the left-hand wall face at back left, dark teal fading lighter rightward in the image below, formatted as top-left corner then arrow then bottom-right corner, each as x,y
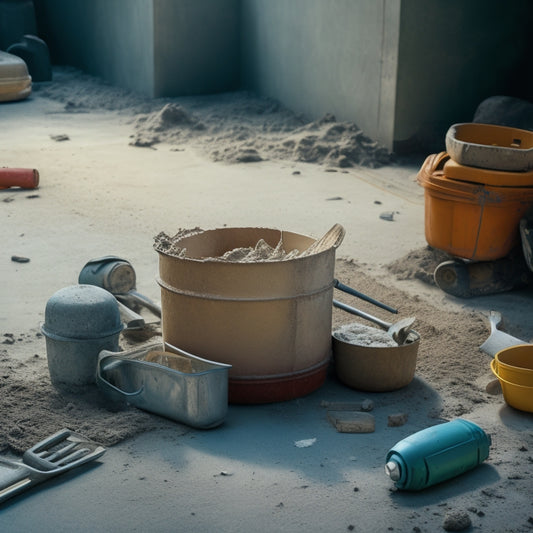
34,0 -> 154,96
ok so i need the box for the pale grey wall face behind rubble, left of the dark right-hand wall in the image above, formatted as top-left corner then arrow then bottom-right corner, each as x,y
241,0 -> 400,150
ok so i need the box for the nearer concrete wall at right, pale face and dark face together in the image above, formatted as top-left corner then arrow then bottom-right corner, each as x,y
241,0 -> 533,152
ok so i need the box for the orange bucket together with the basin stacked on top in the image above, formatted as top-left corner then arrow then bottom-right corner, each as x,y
417,123 -> 533,261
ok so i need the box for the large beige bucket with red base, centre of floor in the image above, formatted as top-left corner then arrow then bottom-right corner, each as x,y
158,228 -> 335,403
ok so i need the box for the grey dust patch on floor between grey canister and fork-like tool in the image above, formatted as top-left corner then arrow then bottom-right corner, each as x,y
0,330 -> 181,455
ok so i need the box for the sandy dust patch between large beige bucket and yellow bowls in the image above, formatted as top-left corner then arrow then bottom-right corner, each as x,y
333,260 -> 494,419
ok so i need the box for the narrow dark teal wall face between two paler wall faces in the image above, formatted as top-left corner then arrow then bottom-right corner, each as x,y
153,0 -> 240,96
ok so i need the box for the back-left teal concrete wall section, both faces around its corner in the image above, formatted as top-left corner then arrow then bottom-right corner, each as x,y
34,0 -> 239,97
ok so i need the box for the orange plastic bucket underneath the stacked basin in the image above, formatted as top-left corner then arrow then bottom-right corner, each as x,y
417,152 -> 533,261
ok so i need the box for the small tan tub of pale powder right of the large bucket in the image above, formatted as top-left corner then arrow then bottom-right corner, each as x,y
333,323 -> 420,392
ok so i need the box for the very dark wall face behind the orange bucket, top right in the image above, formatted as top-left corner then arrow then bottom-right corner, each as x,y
394,0 -> 533,151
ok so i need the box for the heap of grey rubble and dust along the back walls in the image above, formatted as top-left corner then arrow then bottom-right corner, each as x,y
35,67 -> 392,168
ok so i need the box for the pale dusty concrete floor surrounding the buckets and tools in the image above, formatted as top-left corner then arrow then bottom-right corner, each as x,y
0,74 -> 533,532
